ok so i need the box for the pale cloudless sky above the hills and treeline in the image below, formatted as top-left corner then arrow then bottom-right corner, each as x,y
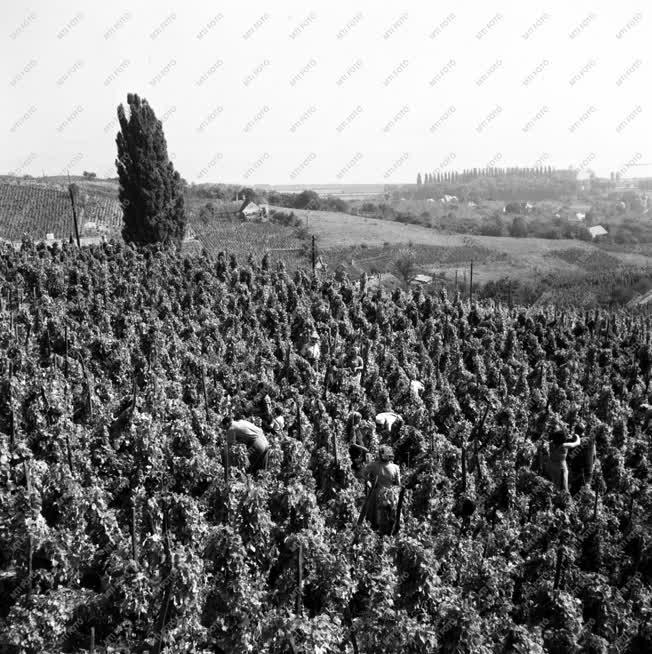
0,0 -> 652,185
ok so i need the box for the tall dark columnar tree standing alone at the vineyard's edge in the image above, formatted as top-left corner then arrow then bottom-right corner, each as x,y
115,93 -> 186,245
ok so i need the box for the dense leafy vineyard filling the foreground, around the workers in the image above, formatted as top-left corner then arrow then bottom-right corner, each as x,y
0,243 -> 652,654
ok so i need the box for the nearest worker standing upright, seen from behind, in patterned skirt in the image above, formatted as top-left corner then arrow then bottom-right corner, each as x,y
362,445 -> 401,534
